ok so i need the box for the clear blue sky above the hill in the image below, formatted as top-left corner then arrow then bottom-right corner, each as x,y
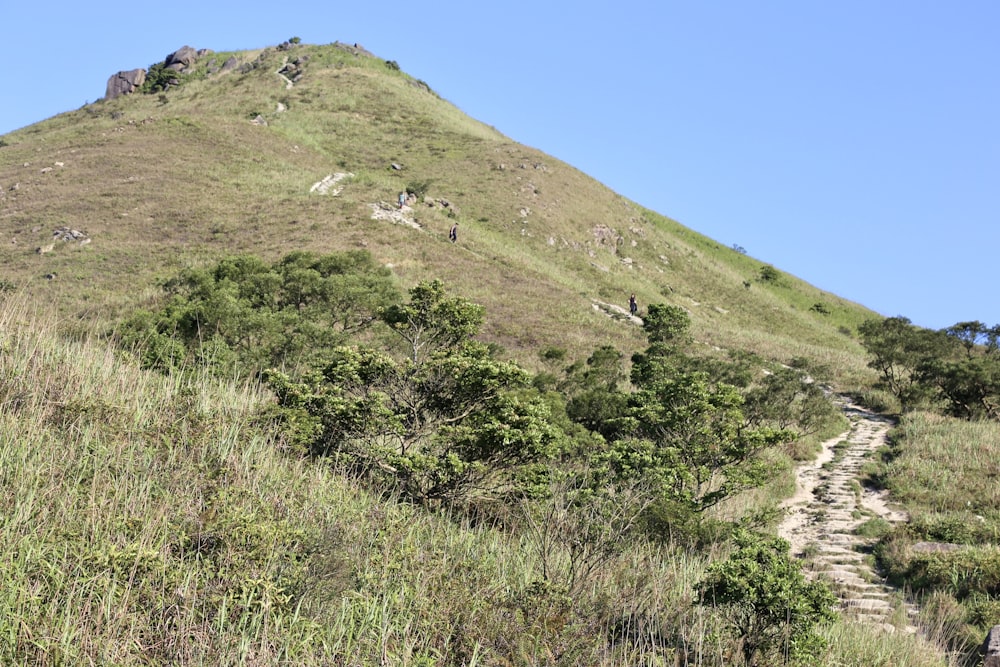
0,0 -> 1000,328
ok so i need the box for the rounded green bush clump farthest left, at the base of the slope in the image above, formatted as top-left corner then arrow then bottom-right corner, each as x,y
119,251 -> 399,375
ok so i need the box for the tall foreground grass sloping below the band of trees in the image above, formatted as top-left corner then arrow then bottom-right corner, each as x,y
0,299 -> 943,667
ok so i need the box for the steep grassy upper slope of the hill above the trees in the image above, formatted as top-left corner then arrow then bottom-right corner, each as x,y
0,44 -> 871,382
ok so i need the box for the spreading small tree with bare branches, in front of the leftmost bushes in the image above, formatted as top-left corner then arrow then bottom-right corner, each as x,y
268,281 -> 559,503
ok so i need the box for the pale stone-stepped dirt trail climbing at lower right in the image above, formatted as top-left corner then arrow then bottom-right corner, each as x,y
778,403 -> 916,632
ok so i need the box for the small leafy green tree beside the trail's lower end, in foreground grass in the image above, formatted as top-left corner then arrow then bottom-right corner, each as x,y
698,531 -> 837,665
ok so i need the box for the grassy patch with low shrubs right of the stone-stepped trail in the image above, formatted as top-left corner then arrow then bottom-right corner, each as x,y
867,412 -> 1000,656
